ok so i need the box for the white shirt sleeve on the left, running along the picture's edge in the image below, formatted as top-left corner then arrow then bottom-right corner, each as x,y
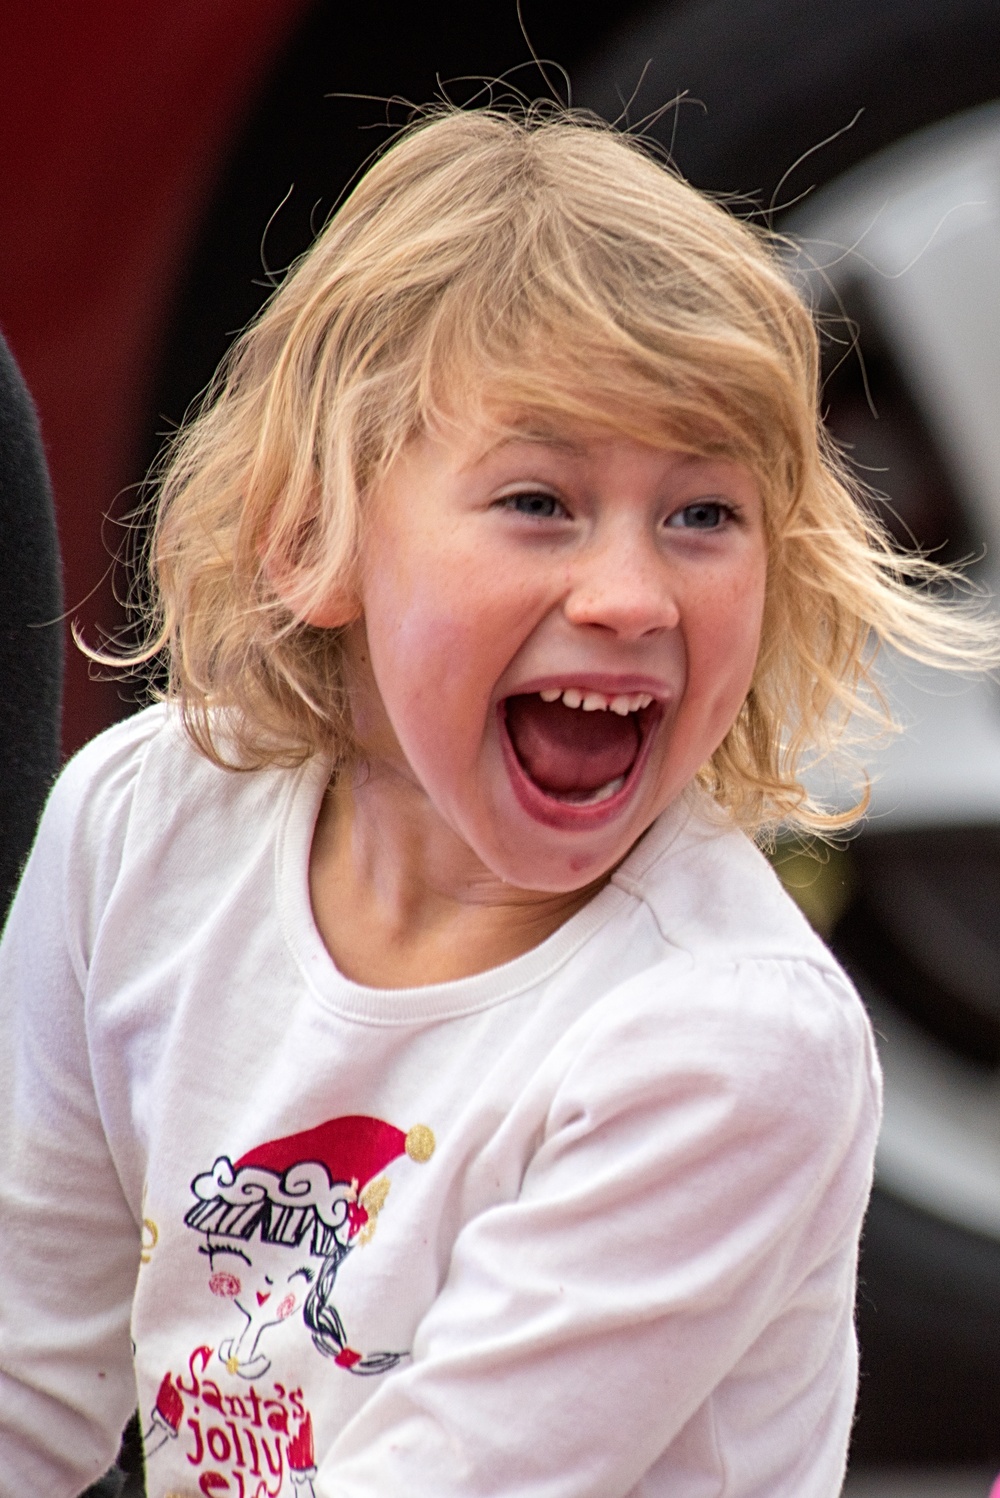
0,722 -> 157,1498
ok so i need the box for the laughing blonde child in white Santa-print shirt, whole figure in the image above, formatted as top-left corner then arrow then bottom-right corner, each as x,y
0,111 -> 987,1498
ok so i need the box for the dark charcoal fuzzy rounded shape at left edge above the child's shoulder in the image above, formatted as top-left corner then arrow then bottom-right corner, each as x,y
0,339 -> 63,924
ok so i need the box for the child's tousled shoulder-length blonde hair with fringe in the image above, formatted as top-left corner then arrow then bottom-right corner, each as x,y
133,106 -> 997,830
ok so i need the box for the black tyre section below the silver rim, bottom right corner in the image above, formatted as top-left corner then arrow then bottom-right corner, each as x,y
850,1189 -> 1000,1468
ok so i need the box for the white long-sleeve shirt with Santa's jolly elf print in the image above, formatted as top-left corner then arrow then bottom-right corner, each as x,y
0,707 -> 879,1498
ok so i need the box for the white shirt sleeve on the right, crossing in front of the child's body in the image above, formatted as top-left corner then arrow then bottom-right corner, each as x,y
324,962 -> 879,1498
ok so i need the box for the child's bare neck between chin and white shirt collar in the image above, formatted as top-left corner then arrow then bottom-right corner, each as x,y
310,761 -> 606,989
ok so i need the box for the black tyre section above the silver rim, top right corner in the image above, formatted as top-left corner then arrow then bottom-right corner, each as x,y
579,0 -> 1000,210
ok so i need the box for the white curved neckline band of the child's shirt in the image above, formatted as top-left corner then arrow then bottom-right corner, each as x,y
274,759 -> 690,1025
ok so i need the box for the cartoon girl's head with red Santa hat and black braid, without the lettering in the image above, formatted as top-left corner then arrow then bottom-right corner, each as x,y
184,1115 -> 434,1378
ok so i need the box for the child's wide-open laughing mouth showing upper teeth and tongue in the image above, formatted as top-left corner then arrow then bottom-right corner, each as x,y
500,686 -> 662,812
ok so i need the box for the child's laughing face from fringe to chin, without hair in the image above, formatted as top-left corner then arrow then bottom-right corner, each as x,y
339,413 -> 768,891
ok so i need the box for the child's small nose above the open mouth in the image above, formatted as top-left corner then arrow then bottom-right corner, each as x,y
563,527 -> 681,640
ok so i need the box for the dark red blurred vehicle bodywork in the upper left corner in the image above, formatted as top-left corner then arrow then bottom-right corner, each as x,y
0,0 -> 305,750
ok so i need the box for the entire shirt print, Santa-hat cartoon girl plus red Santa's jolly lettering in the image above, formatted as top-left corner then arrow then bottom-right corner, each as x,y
144,1115 -> 434,1498
